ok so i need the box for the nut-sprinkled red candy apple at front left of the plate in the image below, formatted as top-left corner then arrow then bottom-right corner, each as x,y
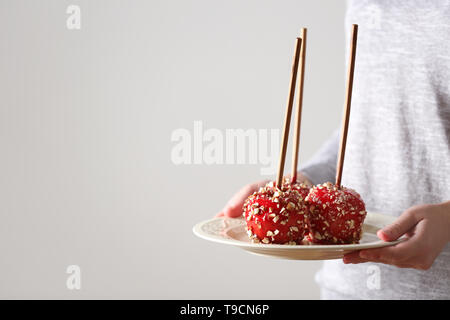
243,182 -> 307,244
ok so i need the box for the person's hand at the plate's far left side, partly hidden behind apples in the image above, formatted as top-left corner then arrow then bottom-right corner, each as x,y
216,173 -> 311,218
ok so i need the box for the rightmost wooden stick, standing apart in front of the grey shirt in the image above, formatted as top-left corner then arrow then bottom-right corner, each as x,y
336,24 -> 358,187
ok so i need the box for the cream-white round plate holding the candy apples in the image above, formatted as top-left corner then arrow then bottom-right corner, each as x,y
193,213 -> 401,260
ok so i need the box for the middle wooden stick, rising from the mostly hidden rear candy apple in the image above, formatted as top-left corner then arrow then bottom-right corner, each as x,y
291,28 -> 306,183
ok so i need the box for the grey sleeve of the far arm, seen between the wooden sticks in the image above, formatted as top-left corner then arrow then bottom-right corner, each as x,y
300,130 -> 339,185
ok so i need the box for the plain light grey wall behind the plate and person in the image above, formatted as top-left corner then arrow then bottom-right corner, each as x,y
0,0 -> 346,299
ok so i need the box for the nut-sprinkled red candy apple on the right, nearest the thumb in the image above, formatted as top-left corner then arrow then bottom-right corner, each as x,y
306,182 -> 367,244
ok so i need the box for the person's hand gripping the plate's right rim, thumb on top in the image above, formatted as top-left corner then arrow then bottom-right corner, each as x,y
343,202 -> 450,270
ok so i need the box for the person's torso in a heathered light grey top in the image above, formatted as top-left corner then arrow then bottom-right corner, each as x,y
319,0 -> 450,298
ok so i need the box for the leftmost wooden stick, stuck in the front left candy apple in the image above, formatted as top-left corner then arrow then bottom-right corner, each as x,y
276,38 -> 302,188
